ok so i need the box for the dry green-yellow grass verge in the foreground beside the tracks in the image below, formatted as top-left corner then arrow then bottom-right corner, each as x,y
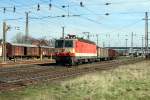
0,61 -> 150,100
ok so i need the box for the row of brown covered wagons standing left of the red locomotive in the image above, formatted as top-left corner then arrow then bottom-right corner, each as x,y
6,43 -> 55,60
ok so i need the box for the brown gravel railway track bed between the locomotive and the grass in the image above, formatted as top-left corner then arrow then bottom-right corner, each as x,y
0,57 -> 144,91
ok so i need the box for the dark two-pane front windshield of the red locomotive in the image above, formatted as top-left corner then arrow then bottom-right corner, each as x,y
55,40 -> 73,48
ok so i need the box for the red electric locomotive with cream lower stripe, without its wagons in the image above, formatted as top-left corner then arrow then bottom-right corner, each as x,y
55,36 -> 97,65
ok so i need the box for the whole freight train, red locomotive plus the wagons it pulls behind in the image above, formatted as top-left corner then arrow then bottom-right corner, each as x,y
55,35 -> 118,65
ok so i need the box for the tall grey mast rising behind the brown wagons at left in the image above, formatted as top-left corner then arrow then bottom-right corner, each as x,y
25,12 -> 29,43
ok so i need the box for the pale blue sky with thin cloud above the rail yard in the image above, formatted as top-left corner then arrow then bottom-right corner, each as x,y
0,0 -> 150,47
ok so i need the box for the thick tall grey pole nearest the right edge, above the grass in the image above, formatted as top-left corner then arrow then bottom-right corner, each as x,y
144,12 -> 149,59
